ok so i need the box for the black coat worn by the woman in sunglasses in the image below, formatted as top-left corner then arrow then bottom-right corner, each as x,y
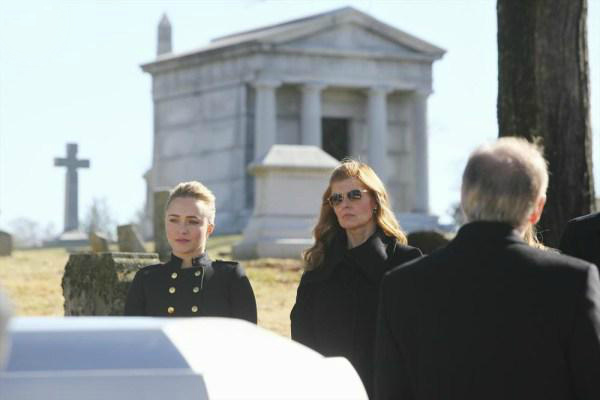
290,231 -> 421,392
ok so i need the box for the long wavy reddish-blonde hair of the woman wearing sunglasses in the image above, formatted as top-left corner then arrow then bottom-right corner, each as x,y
302,159 -> 407,270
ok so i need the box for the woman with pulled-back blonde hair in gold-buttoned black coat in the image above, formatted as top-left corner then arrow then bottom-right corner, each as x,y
125,182 -> 256,323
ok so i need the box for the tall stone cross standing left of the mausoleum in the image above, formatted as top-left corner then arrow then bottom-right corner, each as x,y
54,143 -> 90,232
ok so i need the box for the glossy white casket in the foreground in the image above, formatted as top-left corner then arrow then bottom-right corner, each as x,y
0,317 -> 367,400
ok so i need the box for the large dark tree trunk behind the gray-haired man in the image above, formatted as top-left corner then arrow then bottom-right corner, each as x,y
497,0 -> 595,247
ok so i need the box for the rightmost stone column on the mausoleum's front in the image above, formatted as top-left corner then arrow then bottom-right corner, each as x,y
411,92 -> 429,214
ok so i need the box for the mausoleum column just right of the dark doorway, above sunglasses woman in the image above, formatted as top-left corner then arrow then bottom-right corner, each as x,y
367,86 -> 391,183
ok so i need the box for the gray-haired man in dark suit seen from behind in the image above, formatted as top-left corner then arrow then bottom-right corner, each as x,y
374,138 -> 600,400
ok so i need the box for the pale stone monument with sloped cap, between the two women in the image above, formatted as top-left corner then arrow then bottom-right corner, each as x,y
233,145 -> 339,259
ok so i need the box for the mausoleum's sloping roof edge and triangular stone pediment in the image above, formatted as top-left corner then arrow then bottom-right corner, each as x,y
142,7 -> 445,73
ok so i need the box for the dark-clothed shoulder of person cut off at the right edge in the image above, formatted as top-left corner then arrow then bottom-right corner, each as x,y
560,213 -> 600,266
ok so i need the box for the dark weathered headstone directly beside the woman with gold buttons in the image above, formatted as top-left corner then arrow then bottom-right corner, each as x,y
62,252 -> 159,315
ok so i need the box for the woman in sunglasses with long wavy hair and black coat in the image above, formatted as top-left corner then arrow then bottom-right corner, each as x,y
290,160 -> 421,394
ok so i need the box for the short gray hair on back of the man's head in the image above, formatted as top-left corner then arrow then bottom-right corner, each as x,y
461,137 -> 548,227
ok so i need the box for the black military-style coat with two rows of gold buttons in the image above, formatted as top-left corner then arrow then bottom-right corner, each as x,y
125,254 -> 257,323
